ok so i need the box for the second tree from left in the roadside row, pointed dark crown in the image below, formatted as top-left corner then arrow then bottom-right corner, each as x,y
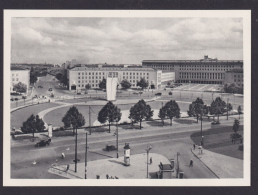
62,106 -> 85,135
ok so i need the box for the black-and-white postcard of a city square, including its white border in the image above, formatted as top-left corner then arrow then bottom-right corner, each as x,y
3,10 -> 251,186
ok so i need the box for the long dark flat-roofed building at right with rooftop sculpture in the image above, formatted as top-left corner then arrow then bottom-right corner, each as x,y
142,56 -> 243,84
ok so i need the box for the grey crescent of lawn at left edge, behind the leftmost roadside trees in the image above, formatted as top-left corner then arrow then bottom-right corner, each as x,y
11,103 -> 58,128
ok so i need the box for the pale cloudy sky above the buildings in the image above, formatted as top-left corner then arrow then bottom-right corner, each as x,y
11,17 -> 243,64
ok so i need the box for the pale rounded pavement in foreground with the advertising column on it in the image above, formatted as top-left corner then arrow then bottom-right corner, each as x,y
48,153 -> 171,179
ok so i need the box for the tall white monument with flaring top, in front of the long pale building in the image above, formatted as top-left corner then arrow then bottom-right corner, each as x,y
106,72 -> 118,101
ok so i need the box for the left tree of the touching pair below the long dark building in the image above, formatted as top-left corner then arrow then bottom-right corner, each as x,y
187,98 -> 208,123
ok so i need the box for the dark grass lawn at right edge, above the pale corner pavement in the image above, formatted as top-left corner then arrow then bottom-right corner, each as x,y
191,125 -> 243,159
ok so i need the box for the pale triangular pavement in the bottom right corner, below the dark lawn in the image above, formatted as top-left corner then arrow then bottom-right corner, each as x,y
192,148 -> 244,178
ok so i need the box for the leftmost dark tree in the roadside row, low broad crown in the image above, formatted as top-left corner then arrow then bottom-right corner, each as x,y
21,114 -> 45,137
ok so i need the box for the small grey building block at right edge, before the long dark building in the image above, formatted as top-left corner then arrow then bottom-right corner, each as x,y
224,69 -> 244,87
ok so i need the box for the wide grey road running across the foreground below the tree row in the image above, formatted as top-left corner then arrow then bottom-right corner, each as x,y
11,118 -> 240,178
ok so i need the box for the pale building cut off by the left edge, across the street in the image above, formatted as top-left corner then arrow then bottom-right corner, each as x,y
10,68 -> 30,92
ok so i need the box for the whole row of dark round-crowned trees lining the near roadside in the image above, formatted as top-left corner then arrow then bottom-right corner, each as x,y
21,97 -> 242,136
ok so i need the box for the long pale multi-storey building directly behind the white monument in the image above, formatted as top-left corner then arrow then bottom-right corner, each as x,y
67,66 -> 165,90
